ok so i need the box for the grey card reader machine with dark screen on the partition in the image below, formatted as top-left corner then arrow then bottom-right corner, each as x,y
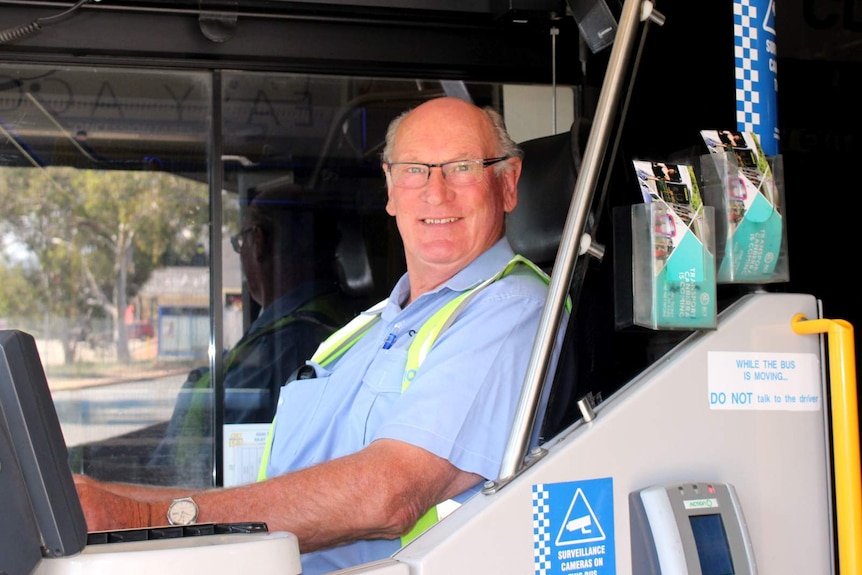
629,481 -> 757,575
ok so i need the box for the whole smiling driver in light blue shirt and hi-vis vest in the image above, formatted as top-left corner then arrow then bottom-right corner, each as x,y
72,98 -> 553,574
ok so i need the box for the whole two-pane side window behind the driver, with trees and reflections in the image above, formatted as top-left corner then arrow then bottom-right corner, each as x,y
0,65 -> 572,487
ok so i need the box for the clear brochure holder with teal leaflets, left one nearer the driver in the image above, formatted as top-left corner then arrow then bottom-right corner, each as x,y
614,202 -> 716,330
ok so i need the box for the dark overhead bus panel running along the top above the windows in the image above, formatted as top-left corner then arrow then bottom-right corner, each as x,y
0,0 -> 592,85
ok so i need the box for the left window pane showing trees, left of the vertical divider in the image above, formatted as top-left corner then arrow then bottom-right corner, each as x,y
0,65 -> 211,486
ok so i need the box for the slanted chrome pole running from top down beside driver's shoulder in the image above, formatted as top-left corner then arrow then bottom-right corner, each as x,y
496,0 -> 648,489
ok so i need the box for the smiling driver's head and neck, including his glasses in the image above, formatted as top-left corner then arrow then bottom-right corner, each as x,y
383,98 -> 521,299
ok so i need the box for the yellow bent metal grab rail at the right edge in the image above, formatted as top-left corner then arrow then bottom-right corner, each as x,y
791,314 -> 862,575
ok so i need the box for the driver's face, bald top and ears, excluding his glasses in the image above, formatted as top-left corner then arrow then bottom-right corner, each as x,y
386,100 -> 520,280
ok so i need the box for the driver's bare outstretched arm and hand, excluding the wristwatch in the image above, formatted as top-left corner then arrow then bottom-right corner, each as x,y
77,439 -> 482,553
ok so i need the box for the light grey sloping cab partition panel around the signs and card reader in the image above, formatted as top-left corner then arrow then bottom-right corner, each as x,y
394,294 -> 832,575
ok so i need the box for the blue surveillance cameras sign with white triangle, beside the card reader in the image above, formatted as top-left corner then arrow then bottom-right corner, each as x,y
533,477 -> 616,575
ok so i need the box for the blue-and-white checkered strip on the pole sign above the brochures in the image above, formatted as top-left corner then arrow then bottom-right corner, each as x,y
733,0 -> 760,132
